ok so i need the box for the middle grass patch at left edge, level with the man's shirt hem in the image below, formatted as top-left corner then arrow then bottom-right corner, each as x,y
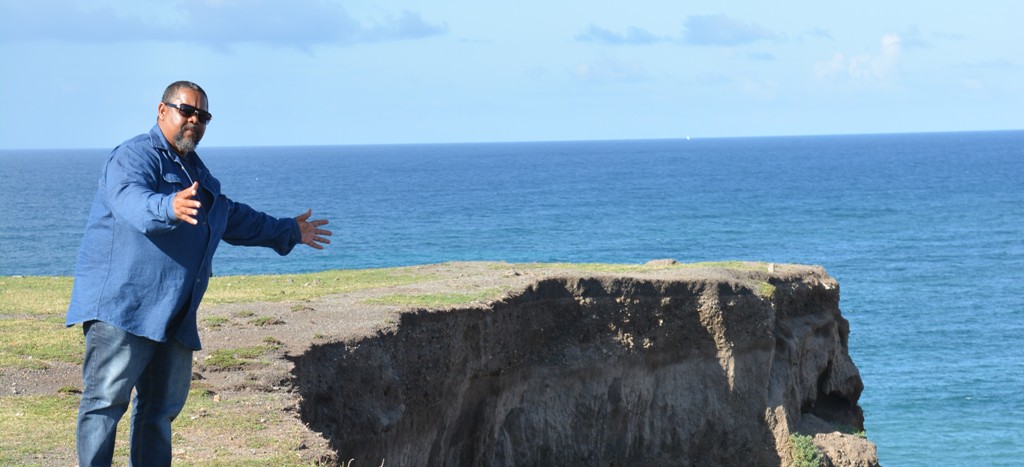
0,317 -> 85,369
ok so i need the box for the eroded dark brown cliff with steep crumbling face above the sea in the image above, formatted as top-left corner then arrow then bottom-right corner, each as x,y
293,263 -> 878,466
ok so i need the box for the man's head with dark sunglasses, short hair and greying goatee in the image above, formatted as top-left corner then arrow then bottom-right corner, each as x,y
157,81 -> 213,156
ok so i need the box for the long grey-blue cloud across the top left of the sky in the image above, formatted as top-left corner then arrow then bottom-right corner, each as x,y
0,0 -> 447,48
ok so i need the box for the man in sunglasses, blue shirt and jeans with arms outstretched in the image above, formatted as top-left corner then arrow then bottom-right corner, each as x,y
67,81 -> 331,467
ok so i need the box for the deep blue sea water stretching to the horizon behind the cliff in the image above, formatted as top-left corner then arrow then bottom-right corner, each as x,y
0,131 -> 1024,466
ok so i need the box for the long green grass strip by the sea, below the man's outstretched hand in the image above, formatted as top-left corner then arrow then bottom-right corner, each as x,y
203,267 -> 436,305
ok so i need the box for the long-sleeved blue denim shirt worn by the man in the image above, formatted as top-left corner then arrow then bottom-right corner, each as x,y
66,126 -> 302,349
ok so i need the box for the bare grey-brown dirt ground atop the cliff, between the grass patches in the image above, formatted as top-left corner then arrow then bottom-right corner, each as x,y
0,261 -> 673,465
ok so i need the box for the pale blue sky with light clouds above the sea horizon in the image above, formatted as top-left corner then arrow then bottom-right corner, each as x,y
0,0 -> 1024,150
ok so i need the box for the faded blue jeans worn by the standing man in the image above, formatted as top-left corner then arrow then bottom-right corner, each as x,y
75,321 -> 193,467
